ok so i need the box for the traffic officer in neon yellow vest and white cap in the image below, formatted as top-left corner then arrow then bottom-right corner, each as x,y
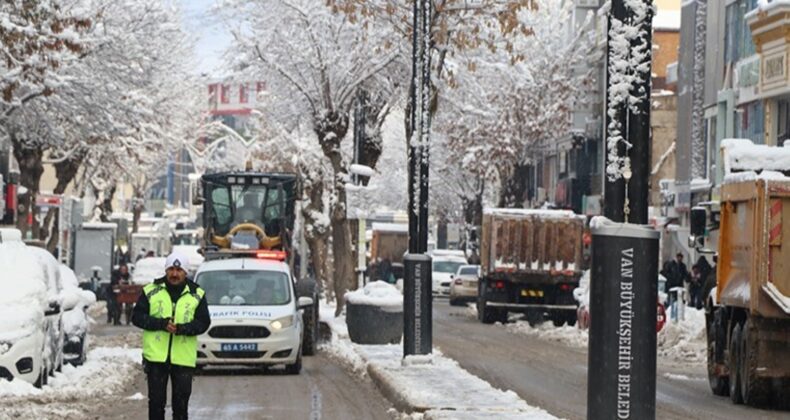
132,253 -> 211,420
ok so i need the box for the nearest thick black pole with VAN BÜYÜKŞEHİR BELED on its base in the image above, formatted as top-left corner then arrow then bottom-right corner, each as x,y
587,0 -> 660,420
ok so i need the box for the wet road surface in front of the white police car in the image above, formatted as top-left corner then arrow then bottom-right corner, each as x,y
99,327 -> 393,420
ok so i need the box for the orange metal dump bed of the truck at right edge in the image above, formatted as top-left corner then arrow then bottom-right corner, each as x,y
717,177 -> 790,318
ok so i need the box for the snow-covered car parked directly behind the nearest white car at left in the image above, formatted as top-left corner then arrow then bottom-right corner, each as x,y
28,246 -> 70,376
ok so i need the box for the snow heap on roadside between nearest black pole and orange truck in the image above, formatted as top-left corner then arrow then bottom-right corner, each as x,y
657,307 -> 707,363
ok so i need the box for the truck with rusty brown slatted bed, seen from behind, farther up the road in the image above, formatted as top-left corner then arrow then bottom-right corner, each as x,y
477,209 -> 586,326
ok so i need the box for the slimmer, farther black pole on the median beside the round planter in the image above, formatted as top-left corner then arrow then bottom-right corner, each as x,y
403,0 -> 433,357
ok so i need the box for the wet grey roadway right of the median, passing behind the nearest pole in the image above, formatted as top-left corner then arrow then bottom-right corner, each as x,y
433,300 -> 790,420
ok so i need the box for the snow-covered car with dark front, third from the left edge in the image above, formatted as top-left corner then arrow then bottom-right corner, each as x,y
60,264 -> 96,366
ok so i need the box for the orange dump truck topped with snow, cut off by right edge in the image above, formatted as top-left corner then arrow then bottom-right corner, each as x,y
690,140 -> 790,406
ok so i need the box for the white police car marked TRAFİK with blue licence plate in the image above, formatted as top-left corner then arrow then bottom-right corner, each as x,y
195,254 -> 314,374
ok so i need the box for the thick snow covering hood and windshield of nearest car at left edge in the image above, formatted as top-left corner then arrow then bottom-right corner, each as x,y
0,235 -> 47,342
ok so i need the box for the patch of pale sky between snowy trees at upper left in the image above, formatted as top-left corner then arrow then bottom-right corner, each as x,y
180,0 -> 231,76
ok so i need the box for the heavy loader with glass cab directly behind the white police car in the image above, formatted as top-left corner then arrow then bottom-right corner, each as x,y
193,170 -> 318,355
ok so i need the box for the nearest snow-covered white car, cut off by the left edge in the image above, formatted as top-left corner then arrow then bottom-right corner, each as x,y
0,229 -> 54,387
